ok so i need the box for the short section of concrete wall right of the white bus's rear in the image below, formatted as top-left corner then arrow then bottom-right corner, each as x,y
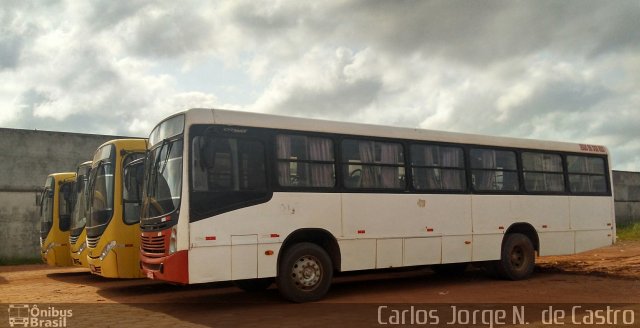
613,171 -> 640,227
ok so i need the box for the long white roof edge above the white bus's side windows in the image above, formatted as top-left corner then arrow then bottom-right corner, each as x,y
172,108 -> 608,154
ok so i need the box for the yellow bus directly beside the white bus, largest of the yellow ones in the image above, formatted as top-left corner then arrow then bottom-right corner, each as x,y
85,139 -> 147,278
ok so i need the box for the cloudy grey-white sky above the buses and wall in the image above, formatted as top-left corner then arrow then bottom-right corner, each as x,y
0,0 -> 640,171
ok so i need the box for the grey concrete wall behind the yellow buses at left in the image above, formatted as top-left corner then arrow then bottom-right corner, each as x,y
0,128 -> 130,259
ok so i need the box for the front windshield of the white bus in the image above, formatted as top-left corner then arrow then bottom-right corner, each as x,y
141,139 -> 183,218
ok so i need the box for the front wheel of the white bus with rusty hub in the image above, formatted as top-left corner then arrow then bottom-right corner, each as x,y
276,243 -> 333,303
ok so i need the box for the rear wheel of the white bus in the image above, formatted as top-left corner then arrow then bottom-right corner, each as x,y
496,233 -> 536,280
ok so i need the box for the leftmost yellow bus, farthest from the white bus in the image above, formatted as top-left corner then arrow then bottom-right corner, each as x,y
38,172 -> 76,266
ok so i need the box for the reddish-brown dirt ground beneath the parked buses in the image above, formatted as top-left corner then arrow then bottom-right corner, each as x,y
0,241 -> 640,327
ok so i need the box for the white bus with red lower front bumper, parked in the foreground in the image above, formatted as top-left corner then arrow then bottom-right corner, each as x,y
140,109 -> 615,302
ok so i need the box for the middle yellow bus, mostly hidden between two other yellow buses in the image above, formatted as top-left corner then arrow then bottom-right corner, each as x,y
69,161 -> 92,268
